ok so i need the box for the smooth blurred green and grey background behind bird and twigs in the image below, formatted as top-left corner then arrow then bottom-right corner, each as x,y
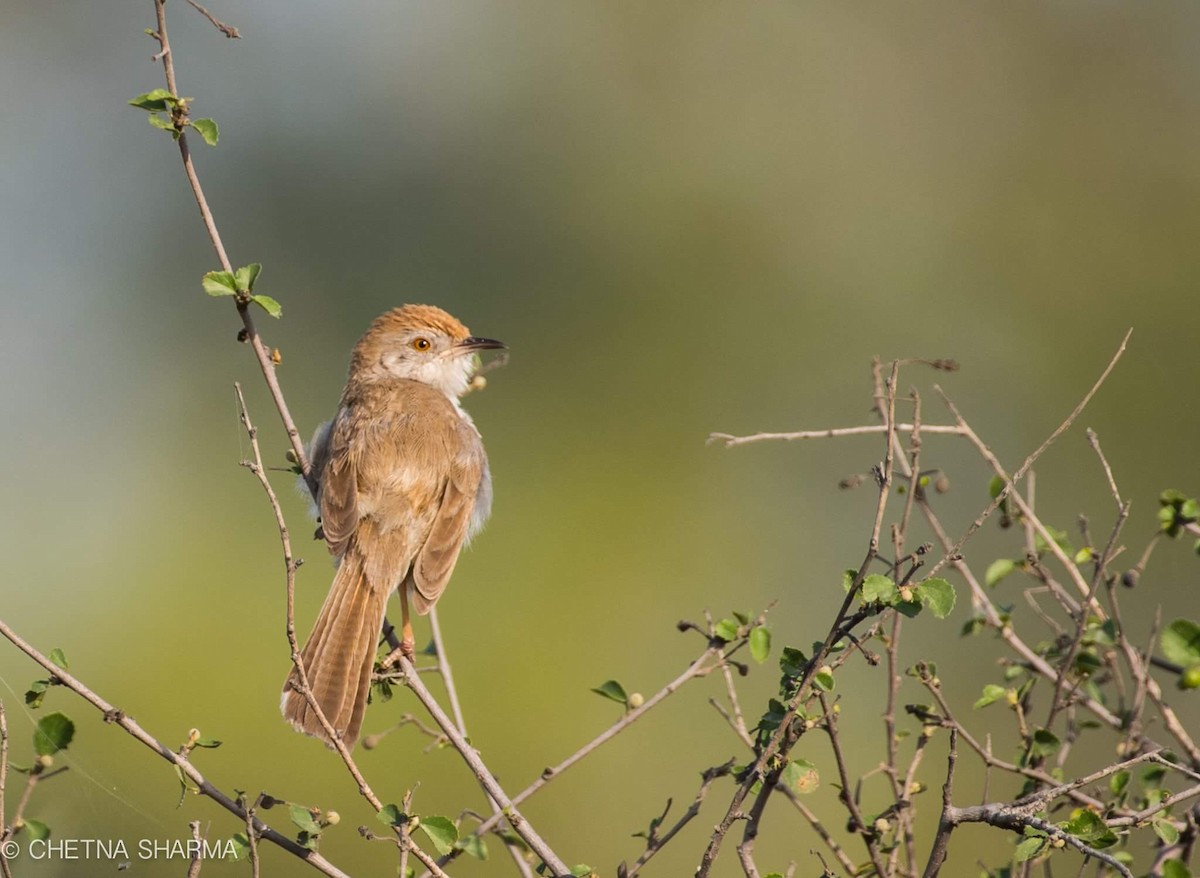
0,0 -> 1200,878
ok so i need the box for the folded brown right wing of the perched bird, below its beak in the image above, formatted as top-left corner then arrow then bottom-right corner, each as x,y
413,446 -> 487,613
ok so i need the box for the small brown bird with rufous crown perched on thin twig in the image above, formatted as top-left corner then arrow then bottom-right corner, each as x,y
282,305 -> 505,746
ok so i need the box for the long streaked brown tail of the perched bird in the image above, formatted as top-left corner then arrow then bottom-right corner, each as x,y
281,545 -> 390,747
